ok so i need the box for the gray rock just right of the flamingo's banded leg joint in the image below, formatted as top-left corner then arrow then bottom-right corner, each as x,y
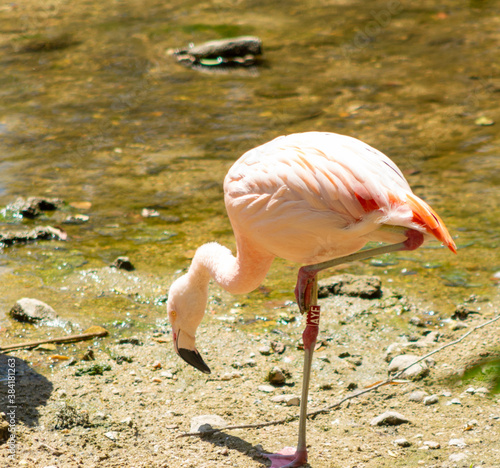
318,274 -> 382,299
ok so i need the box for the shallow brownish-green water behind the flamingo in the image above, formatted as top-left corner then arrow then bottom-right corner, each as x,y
0,0 -> 500,336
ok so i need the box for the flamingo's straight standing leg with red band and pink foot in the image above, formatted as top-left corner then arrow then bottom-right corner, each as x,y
265,275 -> 320,468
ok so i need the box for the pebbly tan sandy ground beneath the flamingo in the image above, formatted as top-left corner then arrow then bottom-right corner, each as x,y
0,276 -> 500,468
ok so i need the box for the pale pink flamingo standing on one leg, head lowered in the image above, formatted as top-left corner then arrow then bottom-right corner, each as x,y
167,132 -> 456,468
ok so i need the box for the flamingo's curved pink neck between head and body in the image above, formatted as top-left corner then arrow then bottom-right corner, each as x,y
188,240 -> 274,294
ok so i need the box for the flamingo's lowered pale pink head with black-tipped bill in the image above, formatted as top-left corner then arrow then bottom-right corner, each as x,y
167,275 -> 210,374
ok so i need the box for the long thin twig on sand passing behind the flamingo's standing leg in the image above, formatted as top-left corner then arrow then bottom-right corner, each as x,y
176,314 -> 500,439
